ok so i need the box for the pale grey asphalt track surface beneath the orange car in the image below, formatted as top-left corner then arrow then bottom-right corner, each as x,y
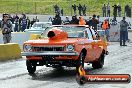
0,33 -> 132,88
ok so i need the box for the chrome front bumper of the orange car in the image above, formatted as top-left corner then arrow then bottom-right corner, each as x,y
21,51 -> 79,56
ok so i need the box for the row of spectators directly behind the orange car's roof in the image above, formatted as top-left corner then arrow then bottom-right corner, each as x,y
52,13 -> 99,30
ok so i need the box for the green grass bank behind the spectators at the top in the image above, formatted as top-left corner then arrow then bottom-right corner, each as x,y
0,0 -> 132,15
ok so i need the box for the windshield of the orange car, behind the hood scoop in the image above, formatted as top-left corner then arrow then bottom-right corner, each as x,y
42,26 -> 85,38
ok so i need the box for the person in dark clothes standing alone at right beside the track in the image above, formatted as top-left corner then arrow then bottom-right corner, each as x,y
120,17 -> 129,46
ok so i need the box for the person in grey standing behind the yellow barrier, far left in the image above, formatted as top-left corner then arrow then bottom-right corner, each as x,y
1,14 -> 12,44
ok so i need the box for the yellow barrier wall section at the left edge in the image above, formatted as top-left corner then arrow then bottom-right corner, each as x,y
0,43 -> 21,61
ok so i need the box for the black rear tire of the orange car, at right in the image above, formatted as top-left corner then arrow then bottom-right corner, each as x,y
92,54 -> 105,69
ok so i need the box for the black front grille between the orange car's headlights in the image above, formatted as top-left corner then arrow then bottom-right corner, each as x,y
33,46 -> 64,51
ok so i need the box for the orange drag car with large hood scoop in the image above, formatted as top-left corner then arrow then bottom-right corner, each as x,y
21,25 -> 108,74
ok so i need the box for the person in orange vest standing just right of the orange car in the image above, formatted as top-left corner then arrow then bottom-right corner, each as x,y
101,19 -> 110,41
